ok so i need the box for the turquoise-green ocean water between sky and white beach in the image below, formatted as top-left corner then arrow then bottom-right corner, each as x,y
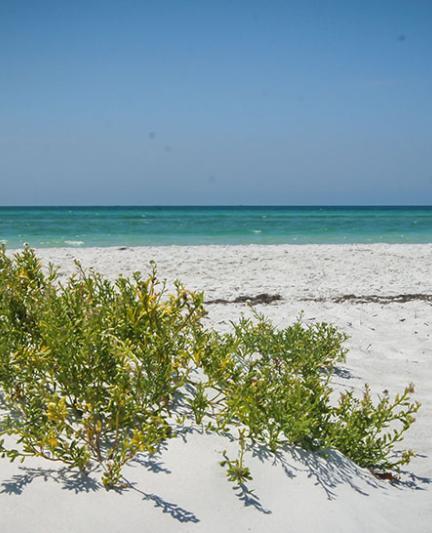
0,206 -> 432,248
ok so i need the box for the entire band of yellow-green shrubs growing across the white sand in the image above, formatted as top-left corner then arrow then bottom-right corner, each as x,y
0,248 -> 419,488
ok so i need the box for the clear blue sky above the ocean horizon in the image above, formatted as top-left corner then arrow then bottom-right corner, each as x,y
0,0 -> 432,205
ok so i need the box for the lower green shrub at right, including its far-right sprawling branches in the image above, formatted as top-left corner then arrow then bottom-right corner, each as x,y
200,315 -> 420,482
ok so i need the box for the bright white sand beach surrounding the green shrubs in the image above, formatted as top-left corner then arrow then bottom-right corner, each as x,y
0,244 -> 432,533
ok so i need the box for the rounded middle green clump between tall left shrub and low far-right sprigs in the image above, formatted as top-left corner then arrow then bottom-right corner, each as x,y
199,317 -> 345,452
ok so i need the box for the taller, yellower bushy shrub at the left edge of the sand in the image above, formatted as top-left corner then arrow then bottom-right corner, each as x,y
0,248 -> 204,487
